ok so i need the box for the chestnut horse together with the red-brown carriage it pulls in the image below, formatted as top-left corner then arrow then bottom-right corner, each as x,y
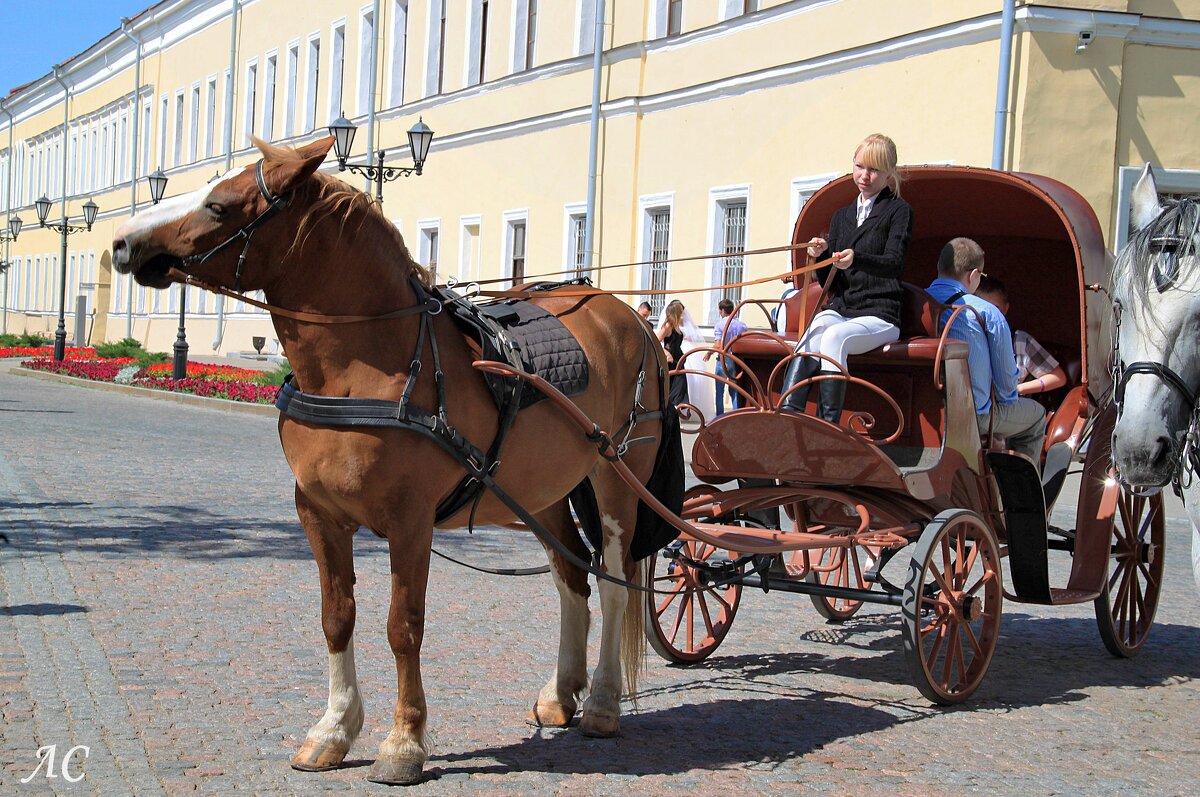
113,139 -> 1164,784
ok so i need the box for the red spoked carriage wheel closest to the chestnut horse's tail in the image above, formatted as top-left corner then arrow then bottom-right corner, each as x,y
646,540 -> 742,664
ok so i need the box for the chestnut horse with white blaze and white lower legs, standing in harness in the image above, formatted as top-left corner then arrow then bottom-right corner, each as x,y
113,138 -> 665,784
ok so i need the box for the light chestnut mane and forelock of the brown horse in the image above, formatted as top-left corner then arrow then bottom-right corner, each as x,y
253,138 -> 433,288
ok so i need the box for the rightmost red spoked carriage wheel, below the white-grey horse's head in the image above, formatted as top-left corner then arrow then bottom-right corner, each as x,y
1096,484 -> 1166,658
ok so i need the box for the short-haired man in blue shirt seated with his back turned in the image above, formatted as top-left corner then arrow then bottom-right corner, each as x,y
929,238 -> 1046,467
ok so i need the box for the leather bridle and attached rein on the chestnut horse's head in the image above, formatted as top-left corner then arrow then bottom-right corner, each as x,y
167,158 -> 442,324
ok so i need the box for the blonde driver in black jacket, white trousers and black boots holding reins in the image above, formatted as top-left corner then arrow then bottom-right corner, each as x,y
782,133 -> 912,424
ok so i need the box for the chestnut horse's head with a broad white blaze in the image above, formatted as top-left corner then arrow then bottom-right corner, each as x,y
113,138 -> 334,290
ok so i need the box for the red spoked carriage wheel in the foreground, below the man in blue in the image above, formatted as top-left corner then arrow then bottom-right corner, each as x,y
901,509 -> 1003,706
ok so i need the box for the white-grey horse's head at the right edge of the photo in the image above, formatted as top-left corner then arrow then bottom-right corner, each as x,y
1112,163 -> 1200,486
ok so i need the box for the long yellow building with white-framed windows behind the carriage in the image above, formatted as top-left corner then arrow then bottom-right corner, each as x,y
0,0 -> 1200,354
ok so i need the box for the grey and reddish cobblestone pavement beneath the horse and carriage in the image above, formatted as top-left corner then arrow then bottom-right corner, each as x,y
0,370 -> 1200,797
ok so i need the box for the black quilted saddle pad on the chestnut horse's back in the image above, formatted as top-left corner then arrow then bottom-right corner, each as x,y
476,299 -> 588,409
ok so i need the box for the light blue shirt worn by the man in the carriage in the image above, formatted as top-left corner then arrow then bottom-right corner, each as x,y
929,277 -> 1016,415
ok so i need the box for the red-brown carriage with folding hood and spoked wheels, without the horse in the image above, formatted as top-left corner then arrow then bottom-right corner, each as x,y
648,167 -> 1164,703
